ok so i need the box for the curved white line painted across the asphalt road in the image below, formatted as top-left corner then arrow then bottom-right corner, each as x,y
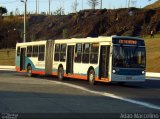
55,81 -> 160,110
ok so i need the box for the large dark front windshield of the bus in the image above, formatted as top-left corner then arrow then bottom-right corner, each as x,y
113,45 -> 146,68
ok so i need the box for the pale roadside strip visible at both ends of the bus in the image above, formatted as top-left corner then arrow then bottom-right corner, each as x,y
0,65 -> 160,78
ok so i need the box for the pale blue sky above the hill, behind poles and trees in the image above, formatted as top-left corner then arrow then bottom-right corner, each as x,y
0,0 -> 157,14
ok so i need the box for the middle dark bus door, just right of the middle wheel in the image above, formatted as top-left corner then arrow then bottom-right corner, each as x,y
66,45 -> 74,74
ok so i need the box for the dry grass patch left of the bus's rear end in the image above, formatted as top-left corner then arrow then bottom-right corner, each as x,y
0,49 -> 15,66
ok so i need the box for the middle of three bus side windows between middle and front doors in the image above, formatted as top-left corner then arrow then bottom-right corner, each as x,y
82,43 -> 90,63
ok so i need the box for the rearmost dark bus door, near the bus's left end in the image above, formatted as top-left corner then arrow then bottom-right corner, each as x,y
20,48 -> 26,71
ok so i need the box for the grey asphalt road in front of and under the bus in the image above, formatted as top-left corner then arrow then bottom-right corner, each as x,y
0,71 -> 160,118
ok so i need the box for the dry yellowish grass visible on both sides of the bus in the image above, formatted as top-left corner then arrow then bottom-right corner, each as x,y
0,35 -> 160,72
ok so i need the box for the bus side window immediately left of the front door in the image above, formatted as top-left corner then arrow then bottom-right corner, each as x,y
90,43 -> 99,64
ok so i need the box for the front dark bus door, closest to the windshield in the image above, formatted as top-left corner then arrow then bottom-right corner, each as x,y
99,45 -> 110,79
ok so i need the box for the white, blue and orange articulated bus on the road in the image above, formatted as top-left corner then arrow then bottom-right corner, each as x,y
16,36 -> 146,85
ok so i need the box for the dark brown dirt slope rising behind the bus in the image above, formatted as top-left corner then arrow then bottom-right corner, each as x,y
0,8 -> 160,48
